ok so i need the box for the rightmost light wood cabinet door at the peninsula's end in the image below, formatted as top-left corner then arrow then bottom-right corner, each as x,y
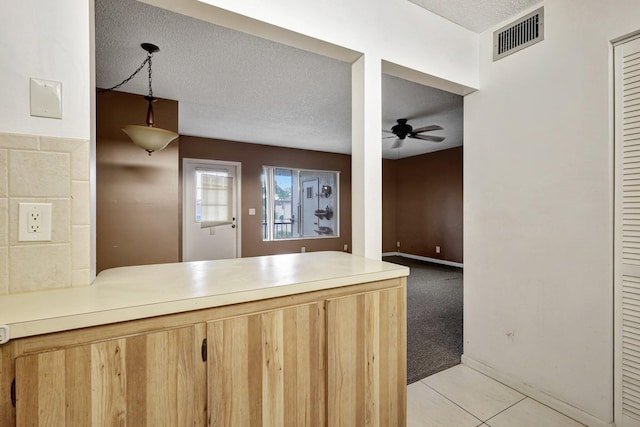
327,286 -> 407,427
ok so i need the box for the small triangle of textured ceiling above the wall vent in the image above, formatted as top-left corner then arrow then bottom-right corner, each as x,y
409,0 -> 541,33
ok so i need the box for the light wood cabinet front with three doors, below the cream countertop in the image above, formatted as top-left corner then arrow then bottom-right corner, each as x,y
0,278 -> 406,427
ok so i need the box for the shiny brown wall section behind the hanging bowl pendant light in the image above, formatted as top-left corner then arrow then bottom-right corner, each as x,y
96,92 -> 180,271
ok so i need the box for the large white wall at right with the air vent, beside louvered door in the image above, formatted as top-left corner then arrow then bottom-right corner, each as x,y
464,0 -> 640,422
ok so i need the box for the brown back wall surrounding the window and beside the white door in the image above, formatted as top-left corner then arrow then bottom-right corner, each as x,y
180,136 -> 351,257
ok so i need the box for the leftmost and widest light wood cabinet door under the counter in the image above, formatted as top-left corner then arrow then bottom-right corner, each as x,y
16,327 -> 205,427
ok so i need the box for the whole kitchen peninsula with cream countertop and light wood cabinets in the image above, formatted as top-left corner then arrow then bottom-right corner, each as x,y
0,252 -> 409,426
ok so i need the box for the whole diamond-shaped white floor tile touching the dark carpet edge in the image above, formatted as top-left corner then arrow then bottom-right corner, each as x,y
422,365 -> 525,421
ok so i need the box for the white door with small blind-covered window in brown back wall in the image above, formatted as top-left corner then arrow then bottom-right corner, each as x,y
182,159 -> 240,261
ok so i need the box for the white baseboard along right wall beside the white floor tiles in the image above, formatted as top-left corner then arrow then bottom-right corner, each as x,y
462,354 -> 615,427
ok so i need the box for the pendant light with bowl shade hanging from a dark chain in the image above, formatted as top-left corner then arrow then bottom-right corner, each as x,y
100,43 -> 178,155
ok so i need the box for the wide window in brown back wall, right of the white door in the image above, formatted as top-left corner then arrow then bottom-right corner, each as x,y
262,166 -> 340,240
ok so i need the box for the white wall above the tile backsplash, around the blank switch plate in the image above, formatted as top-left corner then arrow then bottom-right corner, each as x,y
0,0 -> 93,139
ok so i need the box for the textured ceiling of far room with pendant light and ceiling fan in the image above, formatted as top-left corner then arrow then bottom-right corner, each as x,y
96,0 -> 462,158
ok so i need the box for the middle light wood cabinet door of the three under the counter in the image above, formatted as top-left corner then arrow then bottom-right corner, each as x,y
207,303 -> 325,427
